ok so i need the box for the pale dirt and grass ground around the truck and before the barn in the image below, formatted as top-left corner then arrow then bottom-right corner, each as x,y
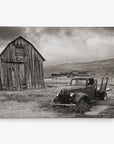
0,77 -> 114,118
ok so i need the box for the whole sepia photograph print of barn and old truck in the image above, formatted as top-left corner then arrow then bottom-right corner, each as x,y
0,26 -> 114,118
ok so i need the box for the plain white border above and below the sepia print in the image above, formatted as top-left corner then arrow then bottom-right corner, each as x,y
0,0 -> 114,144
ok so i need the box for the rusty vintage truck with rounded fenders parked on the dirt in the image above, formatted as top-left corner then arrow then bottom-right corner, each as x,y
53,77 -> 108,112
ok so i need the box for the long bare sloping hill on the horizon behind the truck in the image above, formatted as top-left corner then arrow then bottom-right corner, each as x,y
45,59 -> 114,77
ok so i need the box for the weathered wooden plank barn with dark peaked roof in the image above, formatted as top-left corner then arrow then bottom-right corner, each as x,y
0,36 -> 45,90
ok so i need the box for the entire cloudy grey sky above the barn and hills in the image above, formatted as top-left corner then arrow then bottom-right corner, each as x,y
0,27 -> 114,65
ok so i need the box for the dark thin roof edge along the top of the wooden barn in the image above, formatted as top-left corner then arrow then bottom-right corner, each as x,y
0,36 -> 45,61
